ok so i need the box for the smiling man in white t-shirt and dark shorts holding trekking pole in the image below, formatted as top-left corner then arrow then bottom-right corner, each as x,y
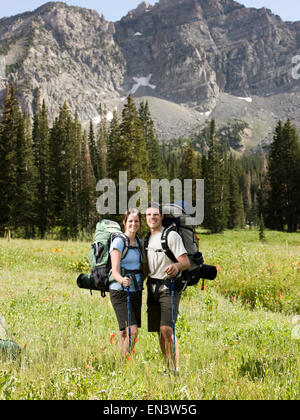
145,203 -> 190,369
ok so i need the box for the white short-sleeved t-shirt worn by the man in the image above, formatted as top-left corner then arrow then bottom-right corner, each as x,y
147,228 -> 187,280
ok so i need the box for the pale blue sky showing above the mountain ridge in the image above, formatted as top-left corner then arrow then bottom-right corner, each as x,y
0,0 -> 300,22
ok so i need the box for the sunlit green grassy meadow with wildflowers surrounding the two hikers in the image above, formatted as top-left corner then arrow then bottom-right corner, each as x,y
0,230 -> 300,400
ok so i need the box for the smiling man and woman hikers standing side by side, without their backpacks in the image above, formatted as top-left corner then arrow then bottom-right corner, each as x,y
110,203 -> 190,368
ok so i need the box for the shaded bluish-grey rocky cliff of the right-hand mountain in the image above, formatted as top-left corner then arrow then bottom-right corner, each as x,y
115,0 -> 299,110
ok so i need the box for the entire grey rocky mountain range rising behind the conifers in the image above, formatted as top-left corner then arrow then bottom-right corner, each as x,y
0,0 -> 300,144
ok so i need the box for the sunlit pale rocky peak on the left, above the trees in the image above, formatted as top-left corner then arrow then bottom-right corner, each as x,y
0,3 -> 125,120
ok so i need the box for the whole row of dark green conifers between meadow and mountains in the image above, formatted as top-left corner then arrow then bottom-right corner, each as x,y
0,86 -> 300,238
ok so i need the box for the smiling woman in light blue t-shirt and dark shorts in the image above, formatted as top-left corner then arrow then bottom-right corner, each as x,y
109,209 -> 143,354
